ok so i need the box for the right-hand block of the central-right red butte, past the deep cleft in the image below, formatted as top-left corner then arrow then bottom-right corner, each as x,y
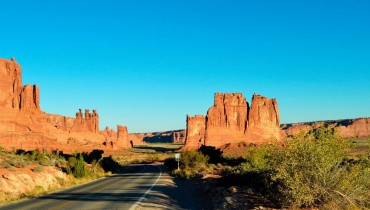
246,94 -> 280,143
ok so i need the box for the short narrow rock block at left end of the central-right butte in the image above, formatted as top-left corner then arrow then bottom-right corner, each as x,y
181,115 -> 206,150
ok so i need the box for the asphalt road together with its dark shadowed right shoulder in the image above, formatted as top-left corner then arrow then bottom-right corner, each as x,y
0,165 -> 205,210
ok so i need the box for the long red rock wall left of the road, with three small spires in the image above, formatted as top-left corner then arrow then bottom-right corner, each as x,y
0,58 -> 130,152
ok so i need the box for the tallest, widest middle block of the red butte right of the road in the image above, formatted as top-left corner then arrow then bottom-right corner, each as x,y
205,93 -> 248,147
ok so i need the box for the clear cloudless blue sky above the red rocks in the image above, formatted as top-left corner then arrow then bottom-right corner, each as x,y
0,0 -> 370,132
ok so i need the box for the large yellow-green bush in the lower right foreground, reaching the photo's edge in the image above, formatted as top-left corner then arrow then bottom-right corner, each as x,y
273,127 -> 370,208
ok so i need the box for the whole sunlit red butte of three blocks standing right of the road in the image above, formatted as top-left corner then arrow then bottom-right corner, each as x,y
183,93 -> 281,149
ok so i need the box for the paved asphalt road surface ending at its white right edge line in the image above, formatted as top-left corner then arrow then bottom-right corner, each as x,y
0,165 -> 162,210
